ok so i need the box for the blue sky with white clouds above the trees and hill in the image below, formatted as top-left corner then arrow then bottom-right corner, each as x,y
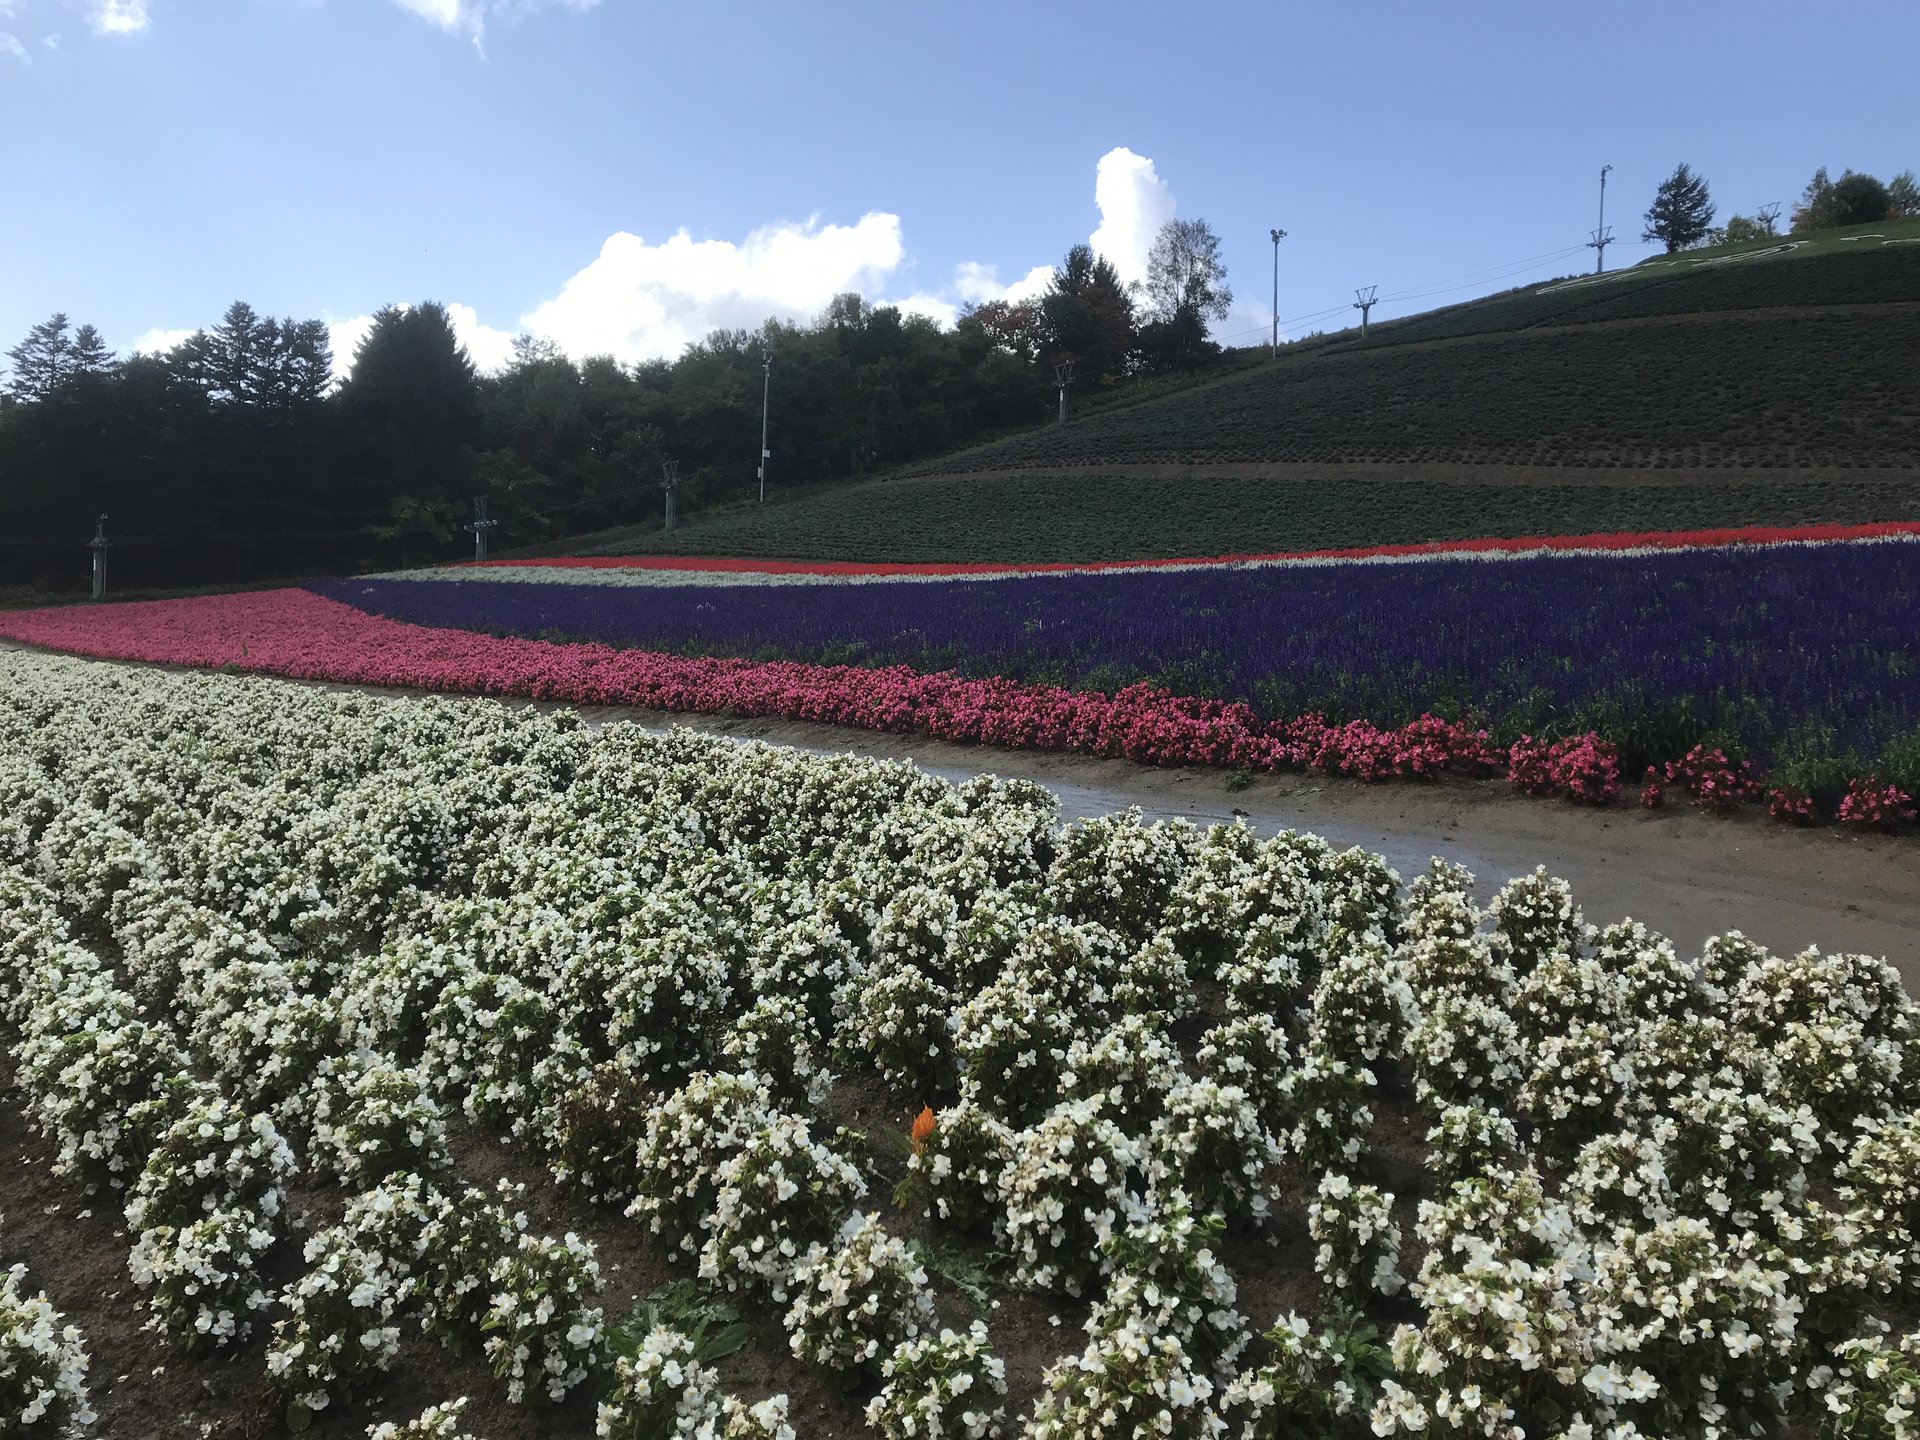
0,0 -> 1920,369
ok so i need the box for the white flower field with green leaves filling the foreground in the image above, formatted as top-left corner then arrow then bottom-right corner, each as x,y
0,656 -> 1920,1440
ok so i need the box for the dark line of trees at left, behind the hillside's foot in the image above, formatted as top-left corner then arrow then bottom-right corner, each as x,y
0,221 -> 1233,589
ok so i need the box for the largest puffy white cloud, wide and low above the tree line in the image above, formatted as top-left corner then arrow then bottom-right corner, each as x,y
522,211 -> 904,361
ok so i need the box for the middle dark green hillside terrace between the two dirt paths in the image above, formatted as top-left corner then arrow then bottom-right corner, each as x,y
906,312 -> 1920,474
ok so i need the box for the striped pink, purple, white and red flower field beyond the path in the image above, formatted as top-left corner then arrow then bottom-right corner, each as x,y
0,522 -> 1920,826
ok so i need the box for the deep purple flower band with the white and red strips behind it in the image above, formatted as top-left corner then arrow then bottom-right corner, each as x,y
337,522 -> 1920,820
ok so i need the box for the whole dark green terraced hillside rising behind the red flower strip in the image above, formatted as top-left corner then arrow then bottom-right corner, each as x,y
556,227 -> 1920,561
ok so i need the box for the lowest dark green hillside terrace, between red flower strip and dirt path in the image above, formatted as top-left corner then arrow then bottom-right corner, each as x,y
570,474 -> 1920,561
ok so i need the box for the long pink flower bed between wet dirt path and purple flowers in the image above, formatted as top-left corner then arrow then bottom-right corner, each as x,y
0,589 -> 1619,803
